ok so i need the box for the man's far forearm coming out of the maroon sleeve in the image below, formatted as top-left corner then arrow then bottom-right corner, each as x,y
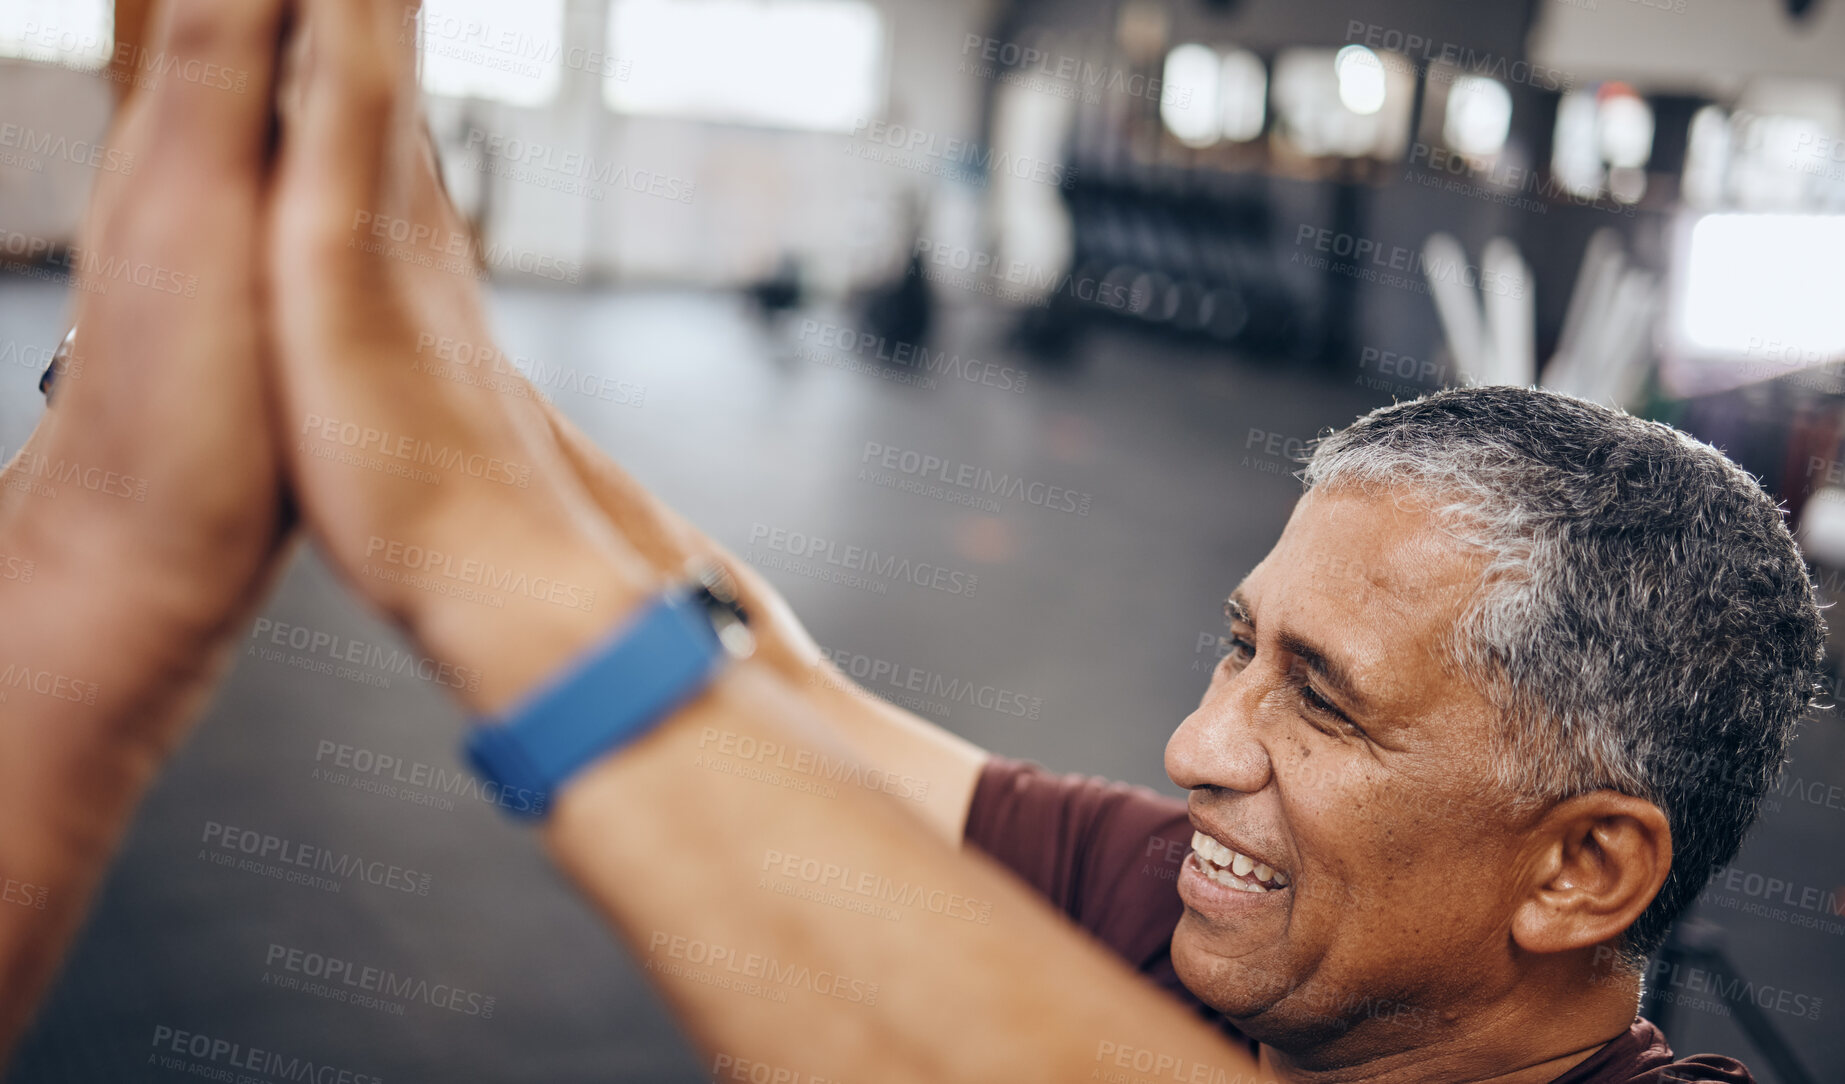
546,406 -> 987,844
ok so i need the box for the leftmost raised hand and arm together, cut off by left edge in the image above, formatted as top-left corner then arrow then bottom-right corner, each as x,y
0,0 -> 286,1060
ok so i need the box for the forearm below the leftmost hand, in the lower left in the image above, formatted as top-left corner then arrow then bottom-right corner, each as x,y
0,479 -> 267,1064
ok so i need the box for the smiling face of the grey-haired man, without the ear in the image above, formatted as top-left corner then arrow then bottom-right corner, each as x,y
1166,490 -> 1530,1066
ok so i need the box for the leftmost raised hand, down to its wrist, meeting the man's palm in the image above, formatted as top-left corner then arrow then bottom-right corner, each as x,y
0,0 -> 284,763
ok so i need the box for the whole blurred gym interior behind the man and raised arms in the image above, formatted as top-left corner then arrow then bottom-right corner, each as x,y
0,0 -> 1845,1084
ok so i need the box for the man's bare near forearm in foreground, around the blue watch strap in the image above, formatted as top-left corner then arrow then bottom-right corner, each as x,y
381,519 -> 1253,1082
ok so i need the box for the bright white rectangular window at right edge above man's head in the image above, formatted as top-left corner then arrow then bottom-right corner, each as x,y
1677,214 -> 1845,363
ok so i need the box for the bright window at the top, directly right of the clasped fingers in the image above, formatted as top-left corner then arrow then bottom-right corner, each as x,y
423,0 -> 564,105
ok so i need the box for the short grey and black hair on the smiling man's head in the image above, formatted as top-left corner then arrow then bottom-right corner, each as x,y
1301,385 -> 1825,962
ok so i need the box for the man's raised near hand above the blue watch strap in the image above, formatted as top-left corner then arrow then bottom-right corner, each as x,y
269,0 -> 661,708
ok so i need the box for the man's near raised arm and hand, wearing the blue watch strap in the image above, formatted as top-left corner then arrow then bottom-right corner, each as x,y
260,0 -> 1255,1082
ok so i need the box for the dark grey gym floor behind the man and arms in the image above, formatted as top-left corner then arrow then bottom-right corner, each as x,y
0,274 -> 1845,1084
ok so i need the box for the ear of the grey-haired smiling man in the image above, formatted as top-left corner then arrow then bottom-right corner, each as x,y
1511,791 -> 1672,953
